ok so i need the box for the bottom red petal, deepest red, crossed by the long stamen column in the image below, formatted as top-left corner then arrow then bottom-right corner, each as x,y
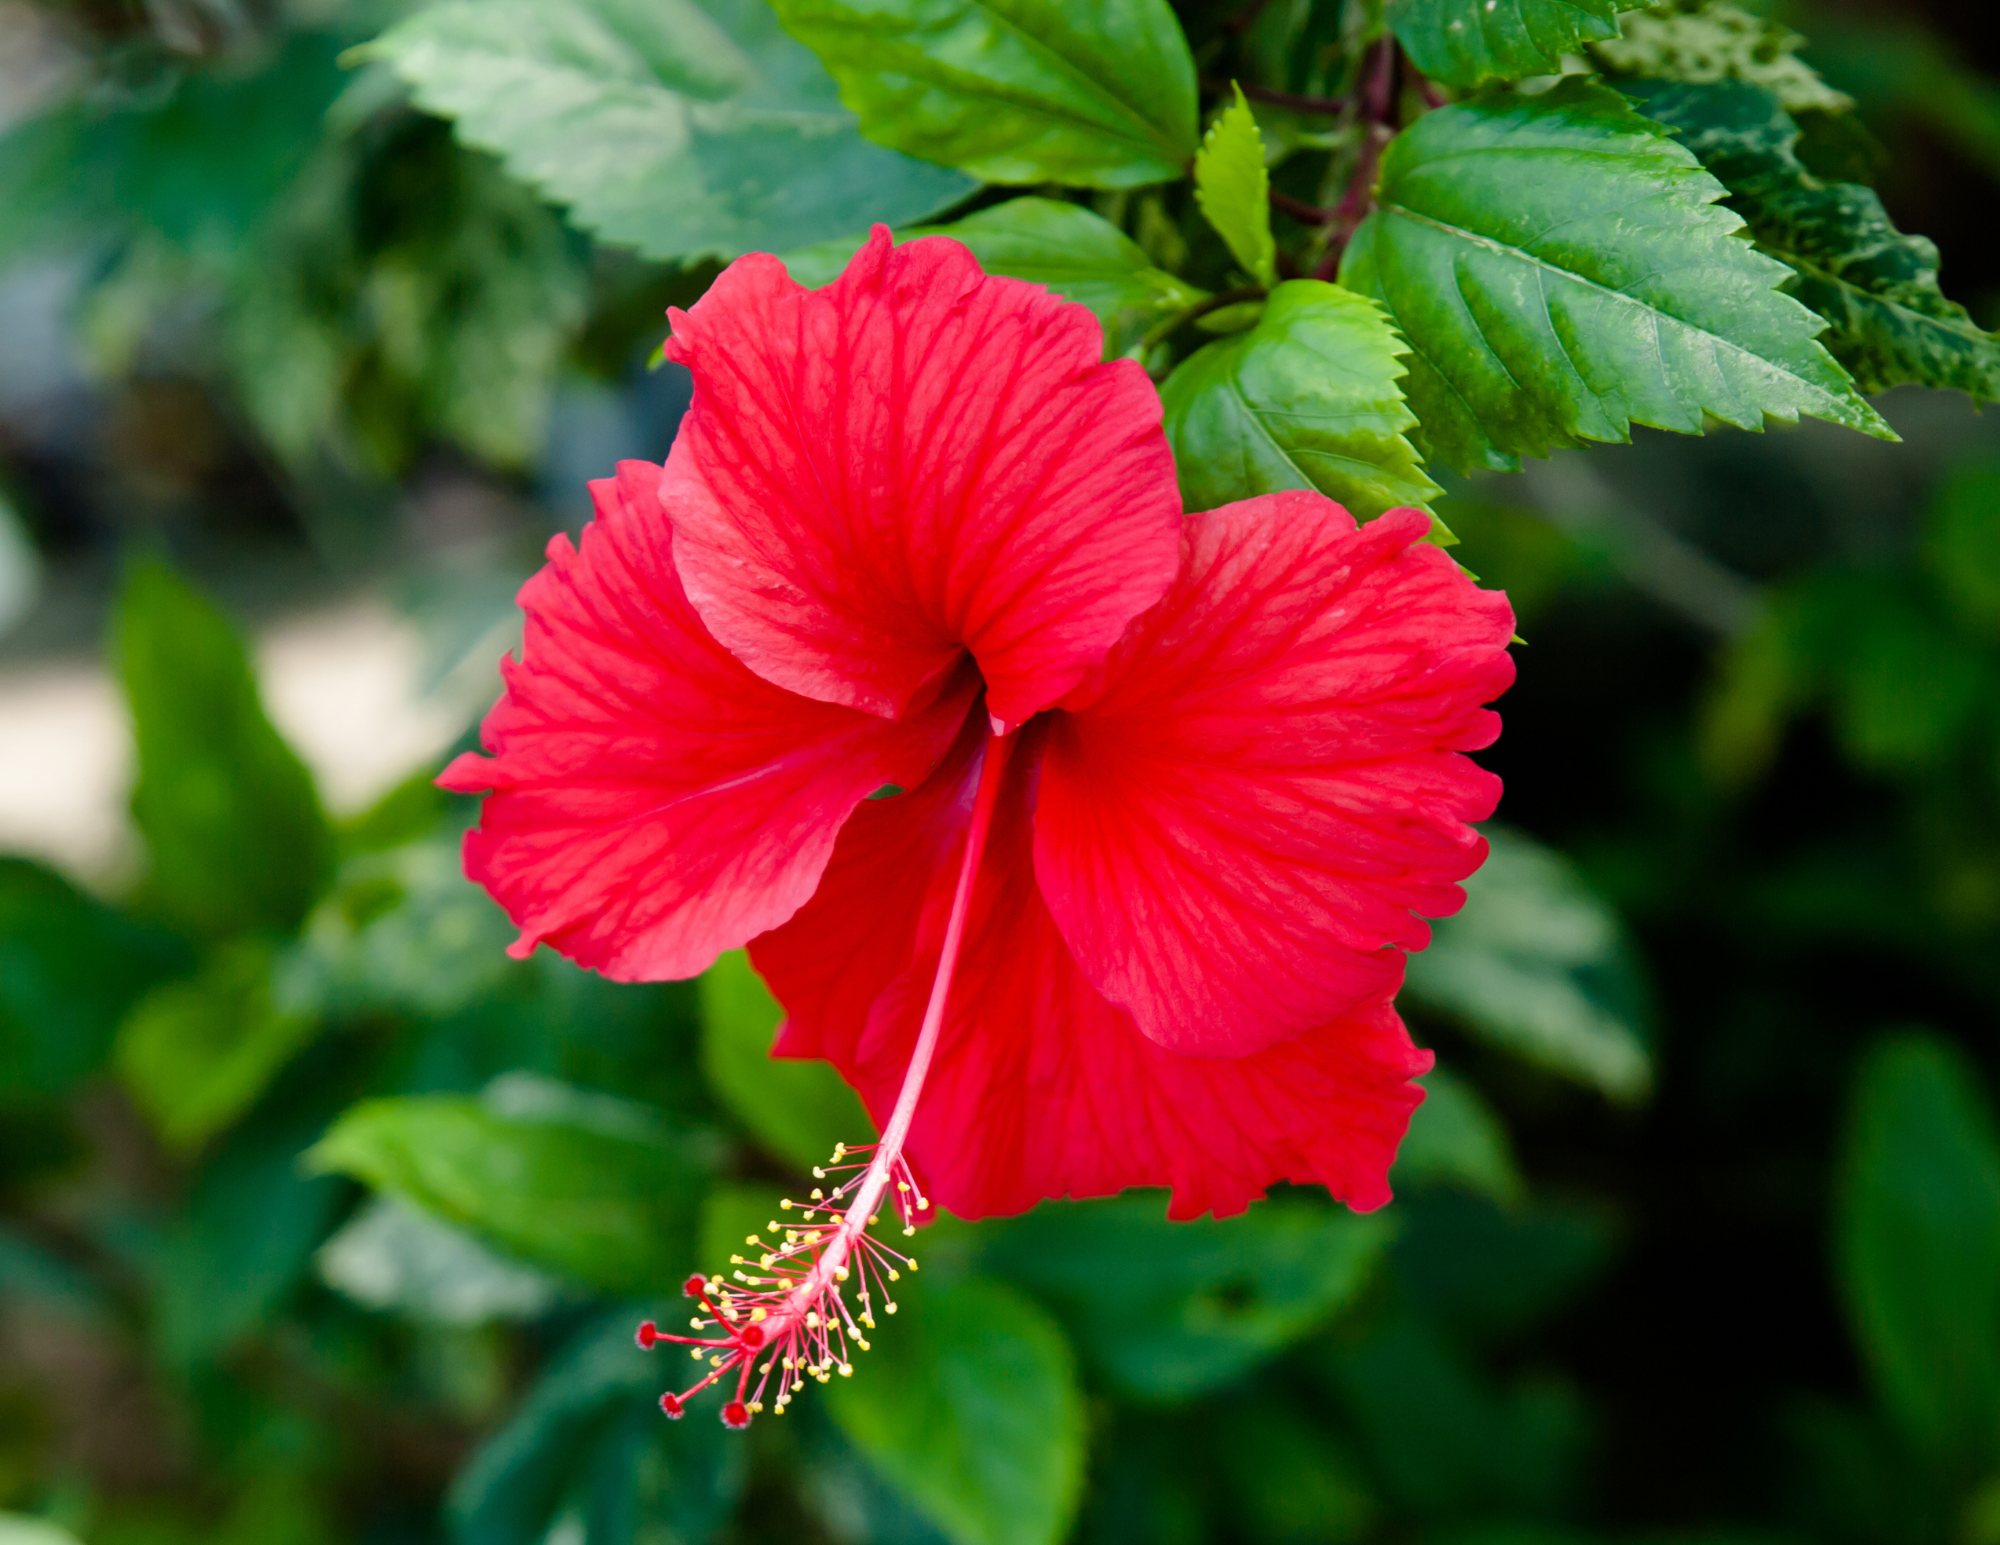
750,730 -> 1432,1219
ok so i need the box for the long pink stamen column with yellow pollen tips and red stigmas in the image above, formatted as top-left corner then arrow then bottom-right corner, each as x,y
638,734 -> 1012,1427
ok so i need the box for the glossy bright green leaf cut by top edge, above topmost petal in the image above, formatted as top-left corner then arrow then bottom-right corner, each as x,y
774,0 -> 1196,188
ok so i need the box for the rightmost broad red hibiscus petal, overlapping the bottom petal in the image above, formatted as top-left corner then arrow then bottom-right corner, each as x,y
1034,492 -> 1514,1057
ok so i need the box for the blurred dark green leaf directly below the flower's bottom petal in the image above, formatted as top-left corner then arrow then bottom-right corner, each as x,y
978,1193 -> 1390,1401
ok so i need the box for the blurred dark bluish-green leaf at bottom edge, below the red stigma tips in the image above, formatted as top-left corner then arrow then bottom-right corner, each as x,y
446,1309 -> 750,1545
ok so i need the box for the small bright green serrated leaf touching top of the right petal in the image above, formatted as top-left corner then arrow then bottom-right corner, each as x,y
1160,278 -> 1440,520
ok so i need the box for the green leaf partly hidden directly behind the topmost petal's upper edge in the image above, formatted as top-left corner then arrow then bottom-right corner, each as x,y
784,196 -> 1208,356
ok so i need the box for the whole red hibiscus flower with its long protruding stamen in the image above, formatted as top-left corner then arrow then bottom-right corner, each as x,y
444,230 -> 1514,1423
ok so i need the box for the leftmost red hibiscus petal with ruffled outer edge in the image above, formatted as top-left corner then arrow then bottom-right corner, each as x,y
440,462 -> 976,981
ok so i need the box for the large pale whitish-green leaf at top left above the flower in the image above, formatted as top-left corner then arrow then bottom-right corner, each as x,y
362,0 -> 972,258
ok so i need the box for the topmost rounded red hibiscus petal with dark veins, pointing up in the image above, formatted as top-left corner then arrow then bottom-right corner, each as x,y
666,226 -> 1180,722
